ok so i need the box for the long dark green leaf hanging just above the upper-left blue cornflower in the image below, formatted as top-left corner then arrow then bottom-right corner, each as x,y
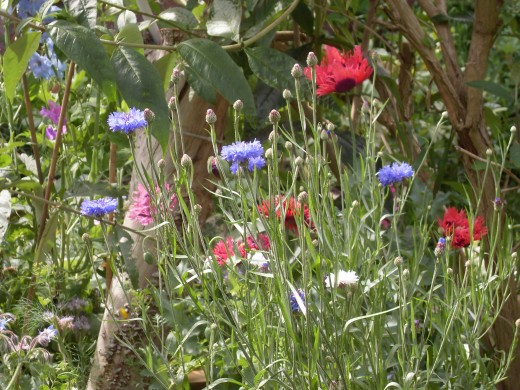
111,46 -> 170,151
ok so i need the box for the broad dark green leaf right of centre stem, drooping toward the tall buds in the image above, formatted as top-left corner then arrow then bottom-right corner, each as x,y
177,38 -> 256,116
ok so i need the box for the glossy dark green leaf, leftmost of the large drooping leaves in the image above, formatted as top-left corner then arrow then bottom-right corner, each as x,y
49,20 -> 115,93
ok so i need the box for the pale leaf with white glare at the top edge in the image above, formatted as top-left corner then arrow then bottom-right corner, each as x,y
206,0 -> 242,42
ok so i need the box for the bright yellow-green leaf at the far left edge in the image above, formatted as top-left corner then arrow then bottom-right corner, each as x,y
2,32 -> 42,103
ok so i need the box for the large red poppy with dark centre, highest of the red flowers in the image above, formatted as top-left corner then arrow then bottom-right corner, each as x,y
304,45 -> 372,96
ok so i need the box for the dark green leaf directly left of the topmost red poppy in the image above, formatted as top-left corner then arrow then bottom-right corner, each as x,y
245,46 -> 296,95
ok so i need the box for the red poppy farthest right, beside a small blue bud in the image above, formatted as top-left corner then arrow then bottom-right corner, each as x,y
437,207 -> 487,248
